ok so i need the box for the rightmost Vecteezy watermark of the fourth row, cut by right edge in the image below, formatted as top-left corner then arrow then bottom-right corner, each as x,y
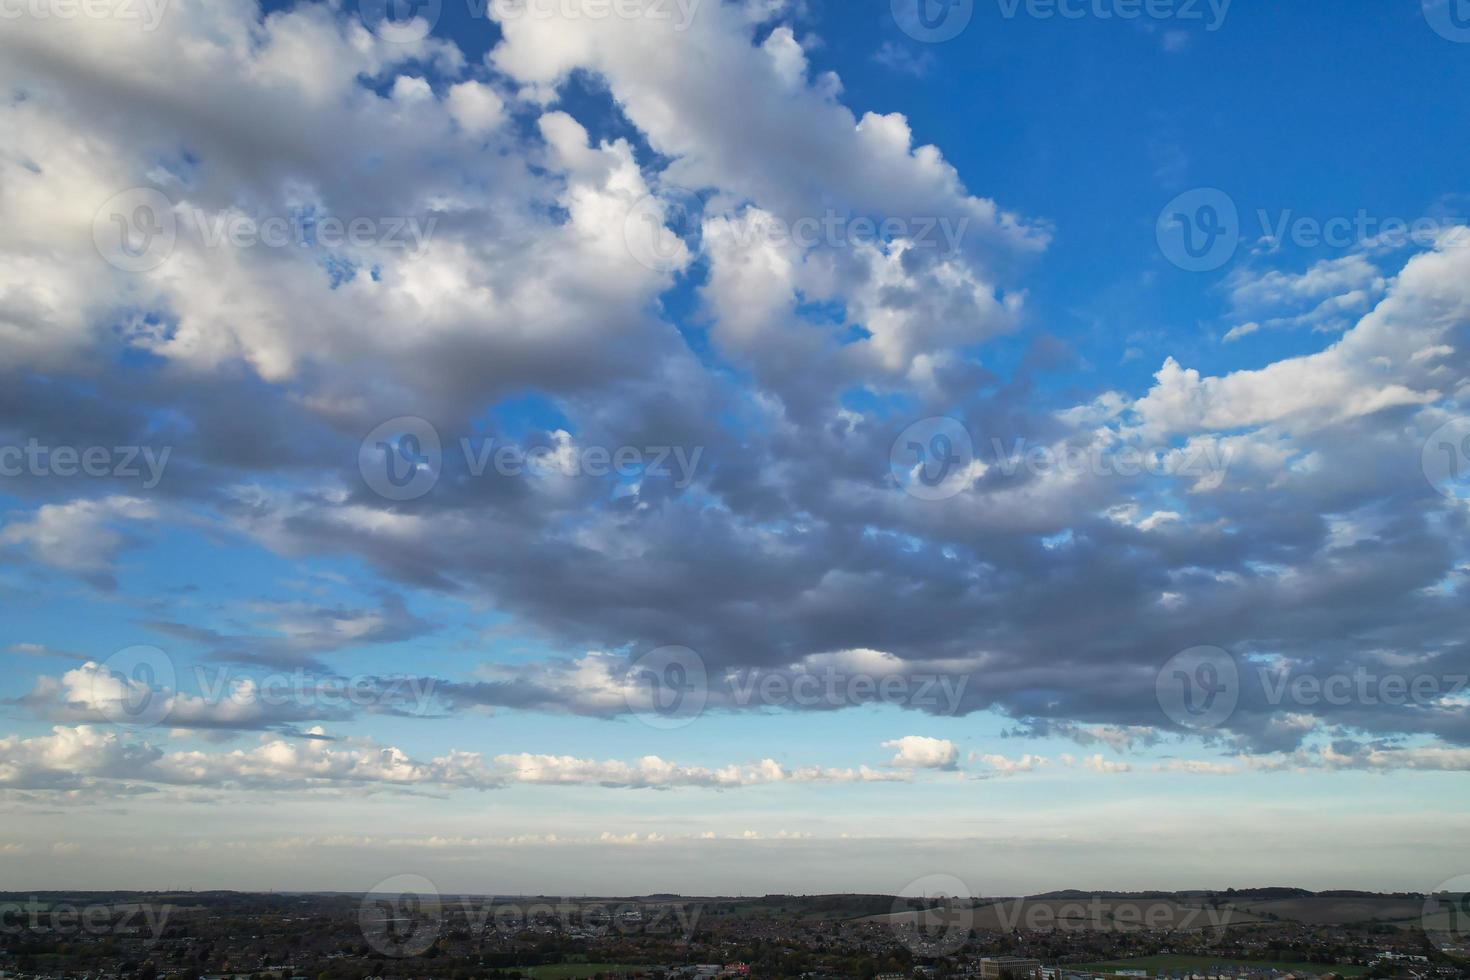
1155,646 -> 1470,730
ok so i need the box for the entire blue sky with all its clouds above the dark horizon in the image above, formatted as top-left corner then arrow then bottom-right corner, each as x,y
0,0 -> 1470,893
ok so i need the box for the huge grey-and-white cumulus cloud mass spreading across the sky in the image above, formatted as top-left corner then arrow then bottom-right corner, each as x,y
0,0 -> 1470,771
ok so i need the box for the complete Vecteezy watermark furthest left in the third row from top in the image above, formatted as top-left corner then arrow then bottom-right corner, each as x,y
357,416 -> 704,501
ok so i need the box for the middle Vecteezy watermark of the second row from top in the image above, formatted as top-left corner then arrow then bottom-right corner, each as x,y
623,188 -> 970,272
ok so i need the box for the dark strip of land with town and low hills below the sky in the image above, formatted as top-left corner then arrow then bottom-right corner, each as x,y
0,889 -> 1470,980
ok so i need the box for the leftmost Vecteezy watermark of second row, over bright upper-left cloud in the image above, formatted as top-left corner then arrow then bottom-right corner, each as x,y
93,187 -> 438,272
